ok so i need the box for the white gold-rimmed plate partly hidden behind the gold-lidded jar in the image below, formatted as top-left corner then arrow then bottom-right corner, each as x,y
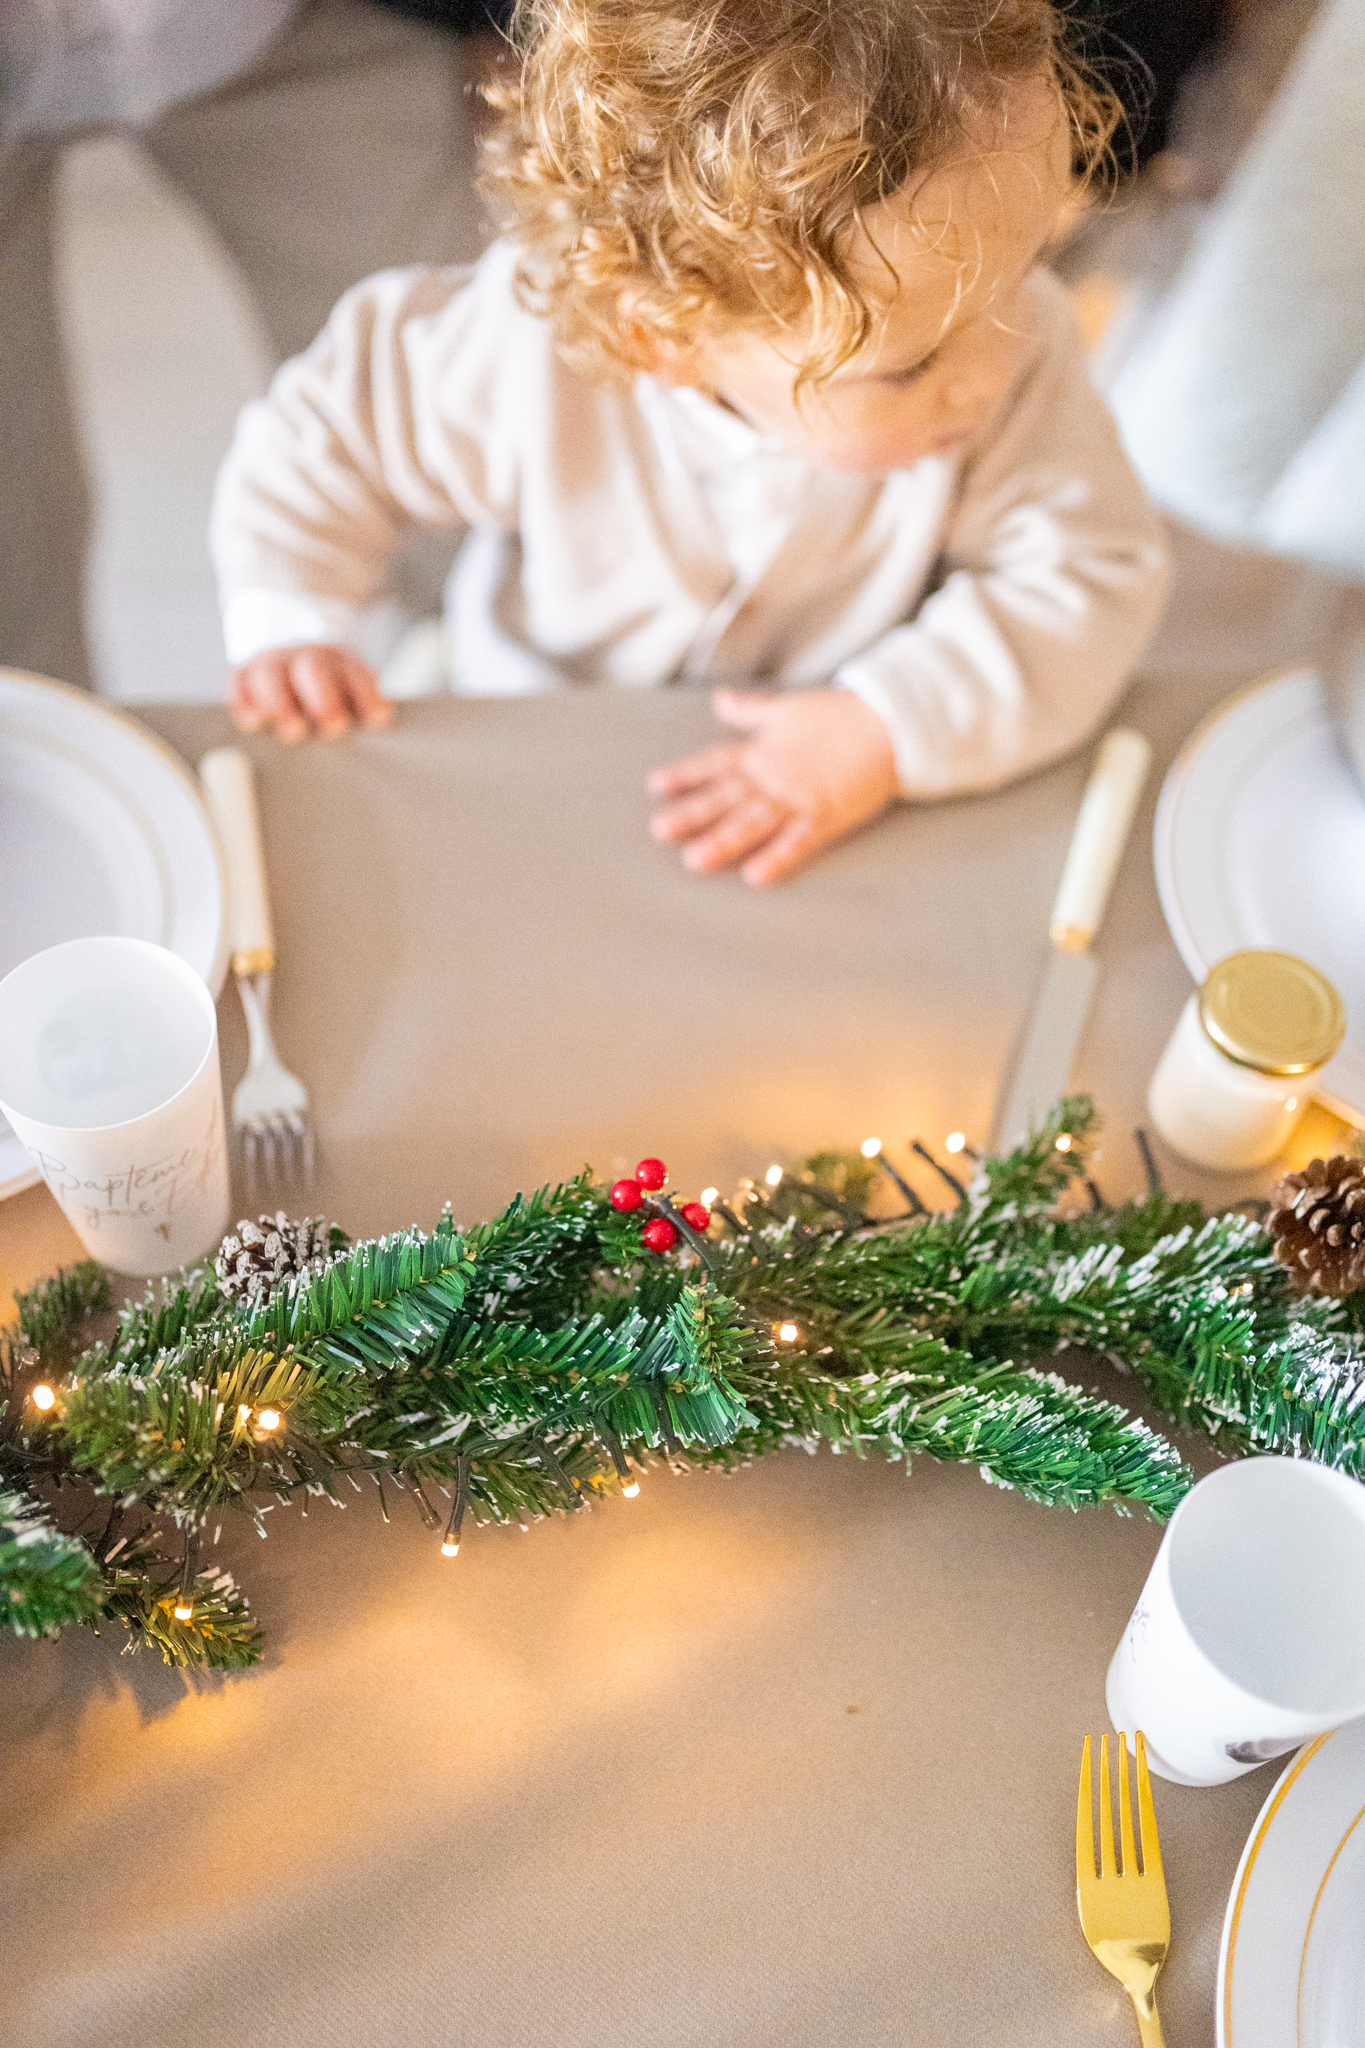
1154,670 -> 1365,1122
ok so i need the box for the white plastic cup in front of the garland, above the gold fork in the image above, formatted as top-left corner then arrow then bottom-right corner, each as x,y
1105,1458 -> 1365,1786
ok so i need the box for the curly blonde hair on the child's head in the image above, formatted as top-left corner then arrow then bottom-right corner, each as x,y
483,0 -> 1119,379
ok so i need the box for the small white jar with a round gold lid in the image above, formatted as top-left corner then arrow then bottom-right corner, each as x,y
1148,948 -> 1347,1174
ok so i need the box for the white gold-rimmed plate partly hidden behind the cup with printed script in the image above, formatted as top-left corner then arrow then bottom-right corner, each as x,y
0,668 -> 227,1198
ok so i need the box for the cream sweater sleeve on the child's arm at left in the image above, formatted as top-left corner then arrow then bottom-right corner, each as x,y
209,258 -> 523,638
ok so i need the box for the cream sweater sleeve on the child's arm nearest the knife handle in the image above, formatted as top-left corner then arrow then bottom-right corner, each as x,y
837,274 -> 1166,797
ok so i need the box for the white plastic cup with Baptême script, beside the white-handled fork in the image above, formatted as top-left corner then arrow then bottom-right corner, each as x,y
0,938 -> 229,1276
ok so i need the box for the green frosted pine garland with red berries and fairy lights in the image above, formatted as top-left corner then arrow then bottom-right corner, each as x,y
0,1098 -> 1365,1667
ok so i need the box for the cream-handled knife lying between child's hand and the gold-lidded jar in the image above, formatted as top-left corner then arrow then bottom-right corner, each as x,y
990,729 -> 1152,1153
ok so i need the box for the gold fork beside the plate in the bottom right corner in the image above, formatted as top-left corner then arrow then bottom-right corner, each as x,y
1076,1731 -> 1171,2048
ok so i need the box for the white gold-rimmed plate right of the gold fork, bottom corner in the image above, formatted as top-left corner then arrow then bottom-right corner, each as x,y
1218,1720 -> 1365,2048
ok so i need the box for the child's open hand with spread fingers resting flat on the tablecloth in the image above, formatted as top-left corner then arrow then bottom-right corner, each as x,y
645,690 -> 896,883
